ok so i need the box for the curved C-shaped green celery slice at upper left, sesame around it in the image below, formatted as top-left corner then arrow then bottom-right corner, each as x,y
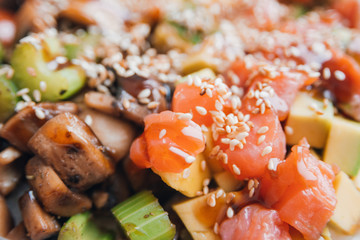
11,38 -> 86,101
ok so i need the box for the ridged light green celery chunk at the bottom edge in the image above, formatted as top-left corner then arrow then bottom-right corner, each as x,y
111,191 -> 176,240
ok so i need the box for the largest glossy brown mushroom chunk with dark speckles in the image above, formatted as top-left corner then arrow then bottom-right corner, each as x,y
29,113 -> 114,190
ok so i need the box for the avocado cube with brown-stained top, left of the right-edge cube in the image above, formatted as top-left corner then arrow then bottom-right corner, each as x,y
285,92 -> 334,148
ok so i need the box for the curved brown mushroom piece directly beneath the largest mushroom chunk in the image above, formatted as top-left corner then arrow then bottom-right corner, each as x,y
26,157 -> 91,217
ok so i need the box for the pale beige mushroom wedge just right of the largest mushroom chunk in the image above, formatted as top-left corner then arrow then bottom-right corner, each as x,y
79,108 -> 135,162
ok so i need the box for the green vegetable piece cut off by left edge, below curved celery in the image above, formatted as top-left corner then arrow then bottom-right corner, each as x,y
0,75 -> 18,122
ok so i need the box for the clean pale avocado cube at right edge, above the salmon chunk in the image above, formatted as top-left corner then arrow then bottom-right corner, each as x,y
324,117 -> 360,177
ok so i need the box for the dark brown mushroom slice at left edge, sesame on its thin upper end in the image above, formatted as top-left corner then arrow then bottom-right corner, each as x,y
0,102 -> 78,152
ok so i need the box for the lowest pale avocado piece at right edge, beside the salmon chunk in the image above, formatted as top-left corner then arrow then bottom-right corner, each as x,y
330,171 -> 360,234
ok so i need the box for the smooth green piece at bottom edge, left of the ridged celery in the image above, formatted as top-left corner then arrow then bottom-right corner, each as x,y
58,212 -> 114,240
